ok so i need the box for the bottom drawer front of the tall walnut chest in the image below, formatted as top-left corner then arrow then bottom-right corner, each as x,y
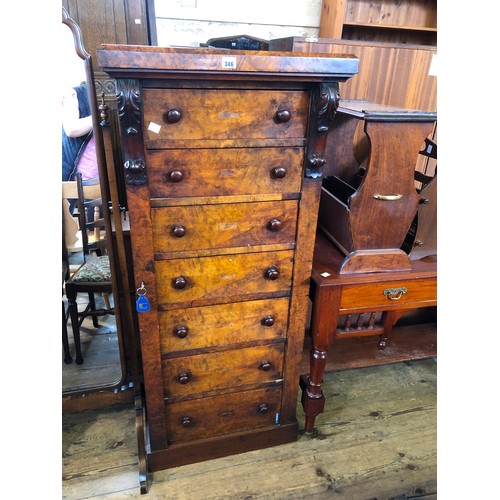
167,387 -> 282,444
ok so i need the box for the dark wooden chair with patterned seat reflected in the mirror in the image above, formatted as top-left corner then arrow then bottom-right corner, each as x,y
63,174 -> 114,364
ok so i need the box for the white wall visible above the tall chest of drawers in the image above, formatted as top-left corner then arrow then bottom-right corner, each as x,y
155,0 -> 322,47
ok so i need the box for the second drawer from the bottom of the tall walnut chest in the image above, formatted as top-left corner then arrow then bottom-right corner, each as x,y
162,343 -> 283,399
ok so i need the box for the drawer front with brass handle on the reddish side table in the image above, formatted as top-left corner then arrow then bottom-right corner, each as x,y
339,279 -> 437,312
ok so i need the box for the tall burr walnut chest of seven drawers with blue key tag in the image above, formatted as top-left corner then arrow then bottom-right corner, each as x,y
97,45 -> 358,470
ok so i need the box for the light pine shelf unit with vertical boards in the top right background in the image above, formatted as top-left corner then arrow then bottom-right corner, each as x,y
316,0 -> 437,111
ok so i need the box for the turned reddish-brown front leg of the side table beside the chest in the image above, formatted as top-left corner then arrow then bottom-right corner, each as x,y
300,286 -> 341,432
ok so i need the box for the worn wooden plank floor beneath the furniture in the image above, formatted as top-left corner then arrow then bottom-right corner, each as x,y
62,358 -> 437,500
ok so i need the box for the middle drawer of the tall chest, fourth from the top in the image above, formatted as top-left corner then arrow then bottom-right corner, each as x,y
155,250 -> 294,308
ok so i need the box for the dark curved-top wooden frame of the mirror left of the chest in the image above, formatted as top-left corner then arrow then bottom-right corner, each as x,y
62,7 -> 132,402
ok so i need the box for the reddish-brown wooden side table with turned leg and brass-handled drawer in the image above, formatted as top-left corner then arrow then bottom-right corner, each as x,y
300,232 -> 437,432
